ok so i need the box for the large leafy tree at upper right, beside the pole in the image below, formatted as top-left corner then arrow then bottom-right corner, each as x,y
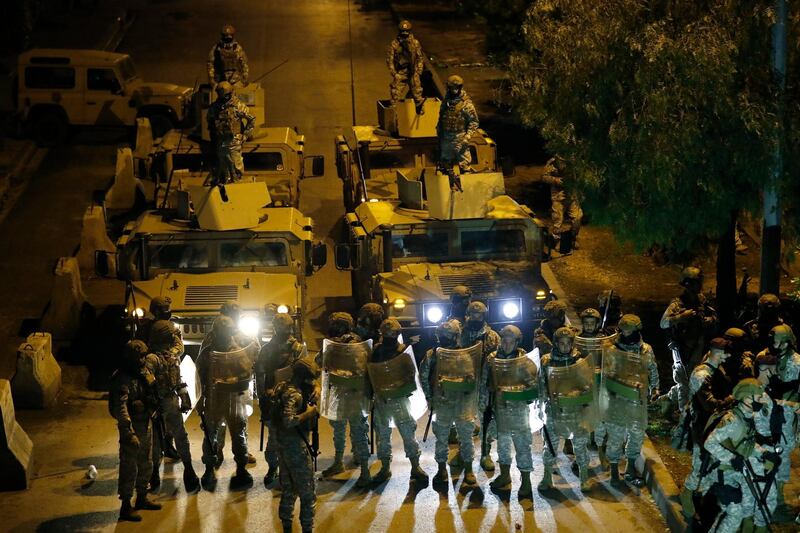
511,0 -> 797,320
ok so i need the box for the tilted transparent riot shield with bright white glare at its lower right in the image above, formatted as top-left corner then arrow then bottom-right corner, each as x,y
367,346 -> 428,420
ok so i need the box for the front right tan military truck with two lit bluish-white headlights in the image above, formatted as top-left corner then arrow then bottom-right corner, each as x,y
335,167 -> 553,355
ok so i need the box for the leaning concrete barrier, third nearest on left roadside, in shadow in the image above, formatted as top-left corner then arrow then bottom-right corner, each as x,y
41,257 -> 86,340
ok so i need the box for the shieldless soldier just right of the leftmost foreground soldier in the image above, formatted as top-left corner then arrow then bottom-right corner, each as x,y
148,320 -> 200,492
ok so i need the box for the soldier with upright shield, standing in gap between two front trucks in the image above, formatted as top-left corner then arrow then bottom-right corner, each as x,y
320,312 -> 372,487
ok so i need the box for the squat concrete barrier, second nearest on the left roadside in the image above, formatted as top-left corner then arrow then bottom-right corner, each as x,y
11,333 -> 61,409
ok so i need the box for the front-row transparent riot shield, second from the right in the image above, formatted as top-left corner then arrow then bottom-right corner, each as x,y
546,357 -> 597,434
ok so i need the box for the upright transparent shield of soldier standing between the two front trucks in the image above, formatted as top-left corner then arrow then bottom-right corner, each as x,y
320,339 -> 372,420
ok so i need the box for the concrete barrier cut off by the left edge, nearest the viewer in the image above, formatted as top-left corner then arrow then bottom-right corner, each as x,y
0,379 -> 33,491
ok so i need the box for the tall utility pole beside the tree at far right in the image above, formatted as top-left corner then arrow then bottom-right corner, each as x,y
760,0 -> 787,294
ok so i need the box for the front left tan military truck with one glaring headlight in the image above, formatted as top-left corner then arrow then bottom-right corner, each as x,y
98,182 -> 326,352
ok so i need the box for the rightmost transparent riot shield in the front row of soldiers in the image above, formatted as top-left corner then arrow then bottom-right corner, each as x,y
599,345 -> 648,426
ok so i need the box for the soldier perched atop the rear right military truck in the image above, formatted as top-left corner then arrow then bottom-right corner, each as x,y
386,20 -> 425,109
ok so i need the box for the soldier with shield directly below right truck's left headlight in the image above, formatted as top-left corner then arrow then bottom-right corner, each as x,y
419,320 -> 481,487
